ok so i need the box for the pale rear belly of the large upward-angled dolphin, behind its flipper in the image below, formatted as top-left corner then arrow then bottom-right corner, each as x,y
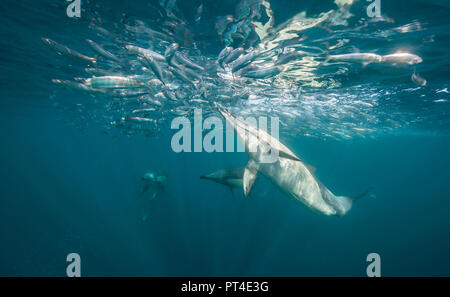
260,158 -> 336,215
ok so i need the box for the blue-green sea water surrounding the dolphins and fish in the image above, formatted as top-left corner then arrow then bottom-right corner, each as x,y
0,0 -> 450,276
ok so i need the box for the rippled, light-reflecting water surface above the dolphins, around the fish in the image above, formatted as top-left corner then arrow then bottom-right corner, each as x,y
3,1 -> 449,139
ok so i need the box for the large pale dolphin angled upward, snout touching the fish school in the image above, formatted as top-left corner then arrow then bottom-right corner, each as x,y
215,103 -> 367,216
